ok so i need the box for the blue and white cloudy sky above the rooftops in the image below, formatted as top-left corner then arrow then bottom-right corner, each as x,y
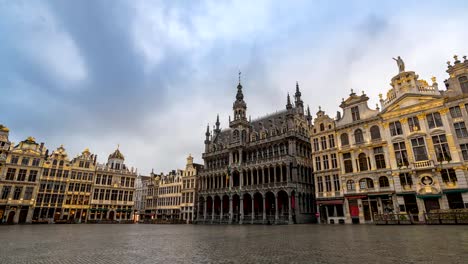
0,0 -> 468,174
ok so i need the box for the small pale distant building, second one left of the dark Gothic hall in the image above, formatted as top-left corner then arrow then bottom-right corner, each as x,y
156,170 -> 184,220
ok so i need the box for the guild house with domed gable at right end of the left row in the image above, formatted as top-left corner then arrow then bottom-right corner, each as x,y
88,148 -> 137,221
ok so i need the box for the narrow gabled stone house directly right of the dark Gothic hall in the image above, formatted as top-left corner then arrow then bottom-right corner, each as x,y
310,107 -> 345,223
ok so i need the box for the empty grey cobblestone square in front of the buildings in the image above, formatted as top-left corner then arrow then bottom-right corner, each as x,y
0,224 -> 468,264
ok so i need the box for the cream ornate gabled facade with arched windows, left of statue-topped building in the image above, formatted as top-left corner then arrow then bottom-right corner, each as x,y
335,91 -> 394,223
